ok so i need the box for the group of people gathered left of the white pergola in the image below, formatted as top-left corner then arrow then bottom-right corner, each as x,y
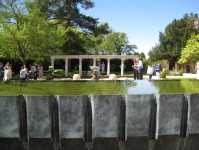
0,62 -> 43,81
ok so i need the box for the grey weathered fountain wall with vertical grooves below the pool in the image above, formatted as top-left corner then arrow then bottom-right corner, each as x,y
0,94 -> 199,150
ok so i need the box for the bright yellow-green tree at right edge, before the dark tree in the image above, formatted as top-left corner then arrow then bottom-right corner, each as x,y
178,34 -> 199,64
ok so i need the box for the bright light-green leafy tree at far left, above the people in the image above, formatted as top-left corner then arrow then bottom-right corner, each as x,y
0,0 -> 64,63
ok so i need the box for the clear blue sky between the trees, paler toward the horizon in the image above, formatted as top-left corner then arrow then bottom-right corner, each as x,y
83,0 -> 199,57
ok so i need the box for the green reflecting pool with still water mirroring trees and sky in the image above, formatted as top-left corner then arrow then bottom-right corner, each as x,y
0,79 -> 199,95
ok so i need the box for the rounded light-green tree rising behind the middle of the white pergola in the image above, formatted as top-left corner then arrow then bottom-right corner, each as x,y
98,32 -> 137,55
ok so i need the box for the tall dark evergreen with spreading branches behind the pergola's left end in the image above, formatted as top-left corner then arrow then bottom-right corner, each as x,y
39,0 -> 111,54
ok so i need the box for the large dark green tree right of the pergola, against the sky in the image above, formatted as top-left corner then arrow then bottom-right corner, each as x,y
149,14 -> 198,63
